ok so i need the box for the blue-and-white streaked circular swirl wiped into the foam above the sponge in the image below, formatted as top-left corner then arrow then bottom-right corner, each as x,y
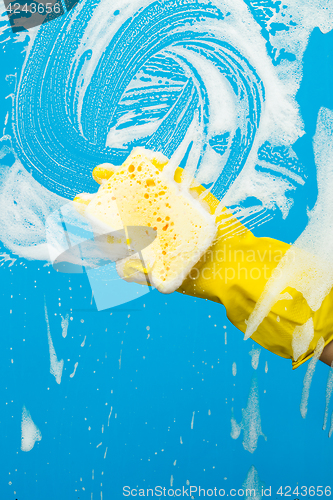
14,1 -> 268,198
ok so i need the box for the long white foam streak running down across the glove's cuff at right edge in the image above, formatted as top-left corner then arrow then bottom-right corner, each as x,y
245,108 -> 333,338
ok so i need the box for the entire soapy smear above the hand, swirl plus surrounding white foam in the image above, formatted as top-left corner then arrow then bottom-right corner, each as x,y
0,0 -> 333,259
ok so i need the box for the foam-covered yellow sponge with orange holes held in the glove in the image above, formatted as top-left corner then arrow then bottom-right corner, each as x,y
85,148 -> 216,293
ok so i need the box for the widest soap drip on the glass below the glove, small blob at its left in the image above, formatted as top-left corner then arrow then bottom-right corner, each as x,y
231,376 -> 267,453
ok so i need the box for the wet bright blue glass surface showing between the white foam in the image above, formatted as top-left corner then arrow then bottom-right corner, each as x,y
0,0 -> 333,500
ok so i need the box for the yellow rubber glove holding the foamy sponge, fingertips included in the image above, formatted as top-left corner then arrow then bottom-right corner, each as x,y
74,160 -> 333,368
